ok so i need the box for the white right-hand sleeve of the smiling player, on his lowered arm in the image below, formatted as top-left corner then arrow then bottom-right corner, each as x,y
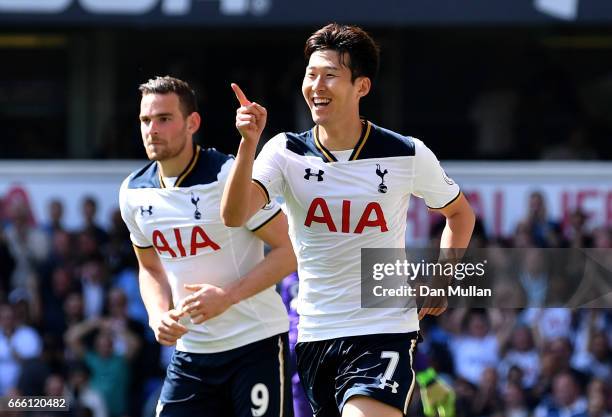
412,138 -> 460,209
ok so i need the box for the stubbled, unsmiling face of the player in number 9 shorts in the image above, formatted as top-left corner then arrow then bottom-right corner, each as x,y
140,93 -> 194,161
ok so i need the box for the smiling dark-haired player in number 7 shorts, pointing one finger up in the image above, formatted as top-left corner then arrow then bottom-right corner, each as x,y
221,24 -> 474,417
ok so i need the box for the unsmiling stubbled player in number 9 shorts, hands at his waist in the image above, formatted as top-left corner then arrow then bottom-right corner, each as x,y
120,77 -> 295,417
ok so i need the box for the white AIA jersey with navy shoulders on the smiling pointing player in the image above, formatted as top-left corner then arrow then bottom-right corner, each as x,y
253,121 -> 460,342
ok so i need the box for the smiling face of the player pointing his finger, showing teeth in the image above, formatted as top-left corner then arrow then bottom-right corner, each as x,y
302,49 -> 369,126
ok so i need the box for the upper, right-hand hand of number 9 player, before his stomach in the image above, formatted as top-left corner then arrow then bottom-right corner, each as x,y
182,284 -> 233,324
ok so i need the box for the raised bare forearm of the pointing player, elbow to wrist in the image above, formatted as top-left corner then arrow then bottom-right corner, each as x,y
221,139 -> 256,227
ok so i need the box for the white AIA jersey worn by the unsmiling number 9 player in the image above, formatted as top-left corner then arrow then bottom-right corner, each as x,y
119,146 -> 289,353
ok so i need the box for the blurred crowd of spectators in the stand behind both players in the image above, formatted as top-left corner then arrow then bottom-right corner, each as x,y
0,192 -> 612,417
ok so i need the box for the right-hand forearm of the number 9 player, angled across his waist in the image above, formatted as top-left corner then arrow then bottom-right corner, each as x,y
225,246 -> 297,304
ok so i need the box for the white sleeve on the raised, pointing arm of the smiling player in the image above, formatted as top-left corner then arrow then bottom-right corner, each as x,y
253,133 -> 286,203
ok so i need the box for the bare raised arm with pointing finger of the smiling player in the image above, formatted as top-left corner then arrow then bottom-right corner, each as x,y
221,84 -> 268,227
